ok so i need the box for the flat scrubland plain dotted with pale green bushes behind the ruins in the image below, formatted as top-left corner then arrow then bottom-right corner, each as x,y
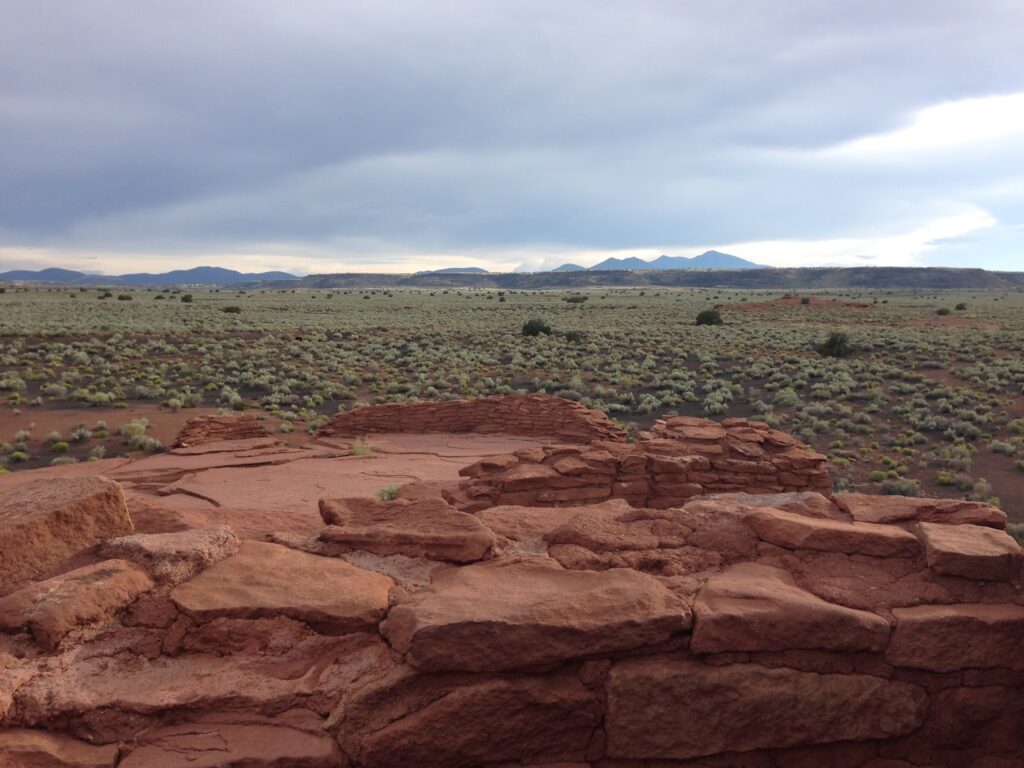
0,285 -> 1024,523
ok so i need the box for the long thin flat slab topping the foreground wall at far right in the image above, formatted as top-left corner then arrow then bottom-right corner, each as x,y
836,494 -> 1007,528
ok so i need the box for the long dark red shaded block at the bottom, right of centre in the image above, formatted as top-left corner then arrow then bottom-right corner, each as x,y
605,656 -> 928,760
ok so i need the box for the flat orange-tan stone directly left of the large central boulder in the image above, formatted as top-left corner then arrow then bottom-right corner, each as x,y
171,542 -> 394,632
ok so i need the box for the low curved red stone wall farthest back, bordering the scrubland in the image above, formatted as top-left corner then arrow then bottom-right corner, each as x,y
316,395 -> 626,442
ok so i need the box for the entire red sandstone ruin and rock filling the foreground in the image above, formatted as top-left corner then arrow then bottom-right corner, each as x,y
0,397 -> 1024,768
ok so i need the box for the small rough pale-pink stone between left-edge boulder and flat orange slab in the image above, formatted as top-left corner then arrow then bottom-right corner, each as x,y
100,525 -> 239,585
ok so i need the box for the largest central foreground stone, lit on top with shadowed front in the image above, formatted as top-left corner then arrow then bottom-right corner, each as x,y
381,558 -> 690,671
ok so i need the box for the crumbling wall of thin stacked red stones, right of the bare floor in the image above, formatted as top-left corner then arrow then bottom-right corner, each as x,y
452,417 -> 831,511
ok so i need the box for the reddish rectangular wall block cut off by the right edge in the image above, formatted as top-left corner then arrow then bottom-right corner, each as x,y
886,603 -> 1024,672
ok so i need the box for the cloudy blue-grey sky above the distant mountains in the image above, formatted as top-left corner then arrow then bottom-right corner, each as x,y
0,0 -> 1024,274
